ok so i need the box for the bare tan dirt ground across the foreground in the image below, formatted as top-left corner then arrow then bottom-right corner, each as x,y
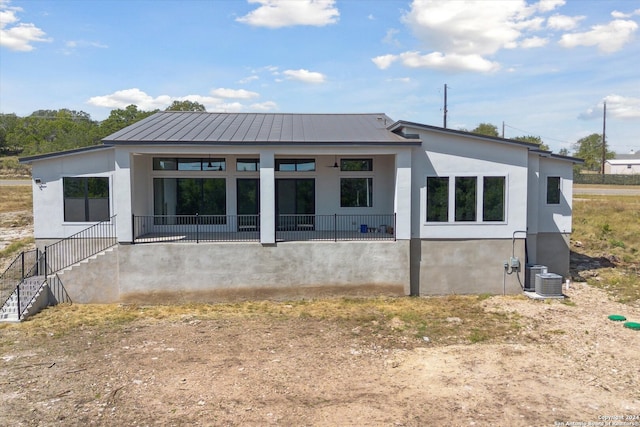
0,283 -> 640,426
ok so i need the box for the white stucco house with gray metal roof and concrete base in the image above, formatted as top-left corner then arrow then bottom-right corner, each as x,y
16,112 -> 579,303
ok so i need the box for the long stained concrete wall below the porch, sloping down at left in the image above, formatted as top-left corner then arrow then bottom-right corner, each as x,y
42,240 -> 409,304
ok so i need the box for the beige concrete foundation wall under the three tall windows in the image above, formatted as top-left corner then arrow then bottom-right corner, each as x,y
411,239 -> 525,295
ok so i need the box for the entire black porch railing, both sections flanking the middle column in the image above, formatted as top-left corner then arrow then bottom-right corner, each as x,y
132,214 -> 396,243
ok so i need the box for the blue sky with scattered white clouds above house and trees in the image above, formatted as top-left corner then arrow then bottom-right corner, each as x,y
0,0 -> 640,153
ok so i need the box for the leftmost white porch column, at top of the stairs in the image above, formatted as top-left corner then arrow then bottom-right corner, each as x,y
111,148 -> 133,243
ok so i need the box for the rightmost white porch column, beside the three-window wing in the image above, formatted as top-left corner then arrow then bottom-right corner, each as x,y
394,148 -> 411,240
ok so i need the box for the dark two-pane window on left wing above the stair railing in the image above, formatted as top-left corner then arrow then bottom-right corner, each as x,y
62,177 -> 109,222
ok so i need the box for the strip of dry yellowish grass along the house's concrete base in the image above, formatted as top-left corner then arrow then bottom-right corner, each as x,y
0,296 -> 520,346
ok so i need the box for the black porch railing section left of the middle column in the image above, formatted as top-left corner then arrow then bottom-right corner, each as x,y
132,214 -> 260,243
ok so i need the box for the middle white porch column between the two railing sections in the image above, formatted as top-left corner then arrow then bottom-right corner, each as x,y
260,151 -> 276,244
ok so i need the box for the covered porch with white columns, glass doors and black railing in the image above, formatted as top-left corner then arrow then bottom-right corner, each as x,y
122,147 -> 411,244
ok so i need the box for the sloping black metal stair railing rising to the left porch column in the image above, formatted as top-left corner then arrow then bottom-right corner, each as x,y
44,215 -> 118,273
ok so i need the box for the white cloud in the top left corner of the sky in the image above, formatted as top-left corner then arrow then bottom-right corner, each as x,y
0,1 -> 51,52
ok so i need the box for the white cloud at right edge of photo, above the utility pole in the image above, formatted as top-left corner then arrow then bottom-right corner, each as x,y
558,19 -> 638,53
